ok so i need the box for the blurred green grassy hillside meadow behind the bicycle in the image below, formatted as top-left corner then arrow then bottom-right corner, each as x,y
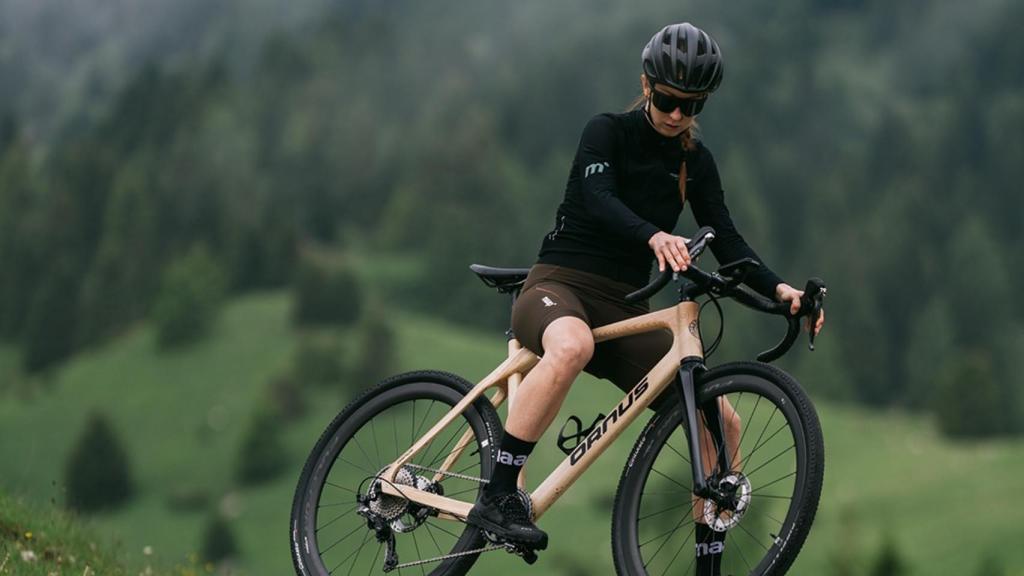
0,293 -> 1024,576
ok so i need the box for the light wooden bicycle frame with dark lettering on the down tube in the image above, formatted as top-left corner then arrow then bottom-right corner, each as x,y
382,301 -> 703,520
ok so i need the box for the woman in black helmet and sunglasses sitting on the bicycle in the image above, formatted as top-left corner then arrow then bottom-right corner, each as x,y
469,23 -> 824,575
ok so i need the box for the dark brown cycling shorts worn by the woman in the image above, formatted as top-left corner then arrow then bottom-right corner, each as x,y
512,264 -> 677,410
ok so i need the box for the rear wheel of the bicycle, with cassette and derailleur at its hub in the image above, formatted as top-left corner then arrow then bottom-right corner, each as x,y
291,372 -> 501,576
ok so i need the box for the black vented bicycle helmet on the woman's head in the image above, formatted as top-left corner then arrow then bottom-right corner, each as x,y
643,22 -> 723,92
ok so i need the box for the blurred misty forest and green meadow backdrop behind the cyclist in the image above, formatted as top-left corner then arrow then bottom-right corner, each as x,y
0,0 -> 1024,575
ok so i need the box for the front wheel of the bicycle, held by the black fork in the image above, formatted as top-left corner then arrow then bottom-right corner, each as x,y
611,362 -> 824,576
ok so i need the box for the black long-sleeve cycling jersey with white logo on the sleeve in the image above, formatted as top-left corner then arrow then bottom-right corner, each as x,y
538,110 -> 782,297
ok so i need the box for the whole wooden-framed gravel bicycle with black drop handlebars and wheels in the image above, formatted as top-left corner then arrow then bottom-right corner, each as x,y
291,228 -> 825,576
